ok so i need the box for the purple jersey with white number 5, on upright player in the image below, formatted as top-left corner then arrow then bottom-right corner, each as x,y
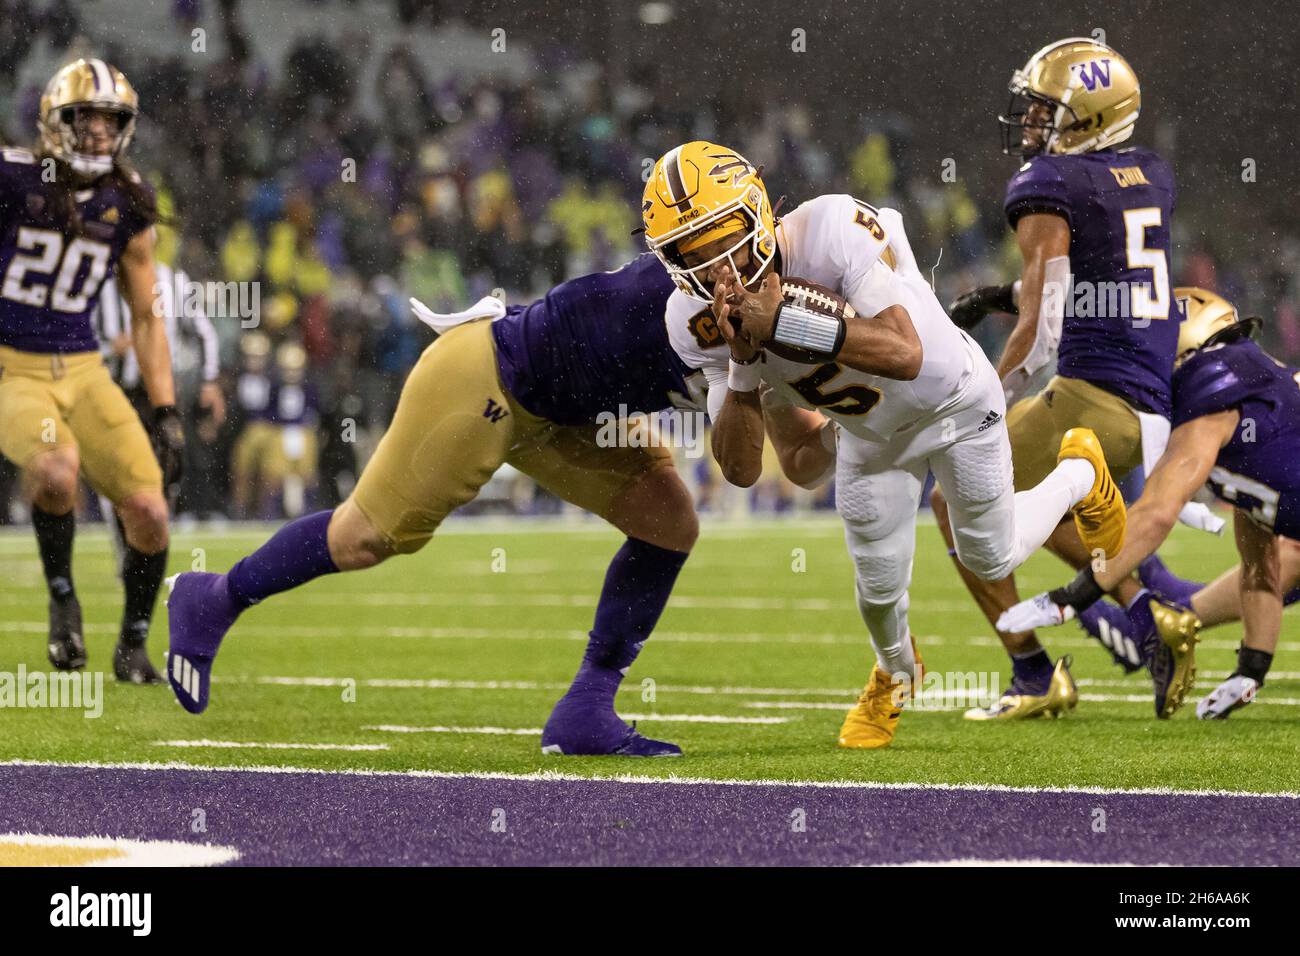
1005,147 -> 1183,416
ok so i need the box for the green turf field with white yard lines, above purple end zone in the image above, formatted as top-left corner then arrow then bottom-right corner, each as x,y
0,519 -> 1300,792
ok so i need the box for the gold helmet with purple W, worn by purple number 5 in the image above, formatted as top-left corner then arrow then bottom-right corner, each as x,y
997,36 -> 1141,155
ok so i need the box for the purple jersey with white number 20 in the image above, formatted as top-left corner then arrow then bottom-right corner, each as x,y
0,148 -> 150,352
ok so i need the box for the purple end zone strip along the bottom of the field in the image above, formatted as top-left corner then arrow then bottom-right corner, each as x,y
0,765 -> 1300,865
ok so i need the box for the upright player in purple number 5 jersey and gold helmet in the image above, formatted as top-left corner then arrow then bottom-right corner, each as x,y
932,38 -> 1182,719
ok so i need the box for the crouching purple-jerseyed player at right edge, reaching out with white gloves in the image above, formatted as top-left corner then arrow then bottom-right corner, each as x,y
998,289 -> 1300,719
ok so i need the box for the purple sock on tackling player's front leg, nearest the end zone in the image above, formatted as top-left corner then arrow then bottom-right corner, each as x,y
569,537 -> 688,705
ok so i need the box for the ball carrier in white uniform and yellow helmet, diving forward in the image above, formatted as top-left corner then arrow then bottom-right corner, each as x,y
642,142 -> 1125,748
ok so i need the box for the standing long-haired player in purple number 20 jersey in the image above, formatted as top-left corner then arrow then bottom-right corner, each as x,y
0,60 -> 185,684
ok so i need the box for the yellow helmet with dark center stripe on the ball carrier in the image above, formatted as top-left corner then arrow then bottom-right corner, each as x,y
641,140 -> 776,302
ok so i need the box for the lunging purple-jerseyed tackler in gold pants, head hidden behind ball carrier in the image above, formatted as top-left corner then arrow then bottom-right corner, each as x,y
168,254 -> 703,757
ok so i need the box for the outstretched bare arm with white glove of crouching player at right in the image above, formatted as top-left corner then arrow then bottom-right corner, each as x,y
997,408 -> 1240,633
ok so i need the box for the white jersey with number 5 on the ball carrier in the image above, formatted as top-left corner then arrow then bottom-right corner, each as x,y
667,194 -> 992,442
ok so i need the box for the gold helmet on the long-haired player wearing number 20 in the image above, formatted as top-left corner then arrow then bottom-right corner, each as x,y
38,60 -> 139,177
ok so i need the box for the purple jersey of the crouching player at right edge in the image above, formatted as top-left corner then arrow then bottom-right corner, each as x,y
1173,339 -> 1300,538
